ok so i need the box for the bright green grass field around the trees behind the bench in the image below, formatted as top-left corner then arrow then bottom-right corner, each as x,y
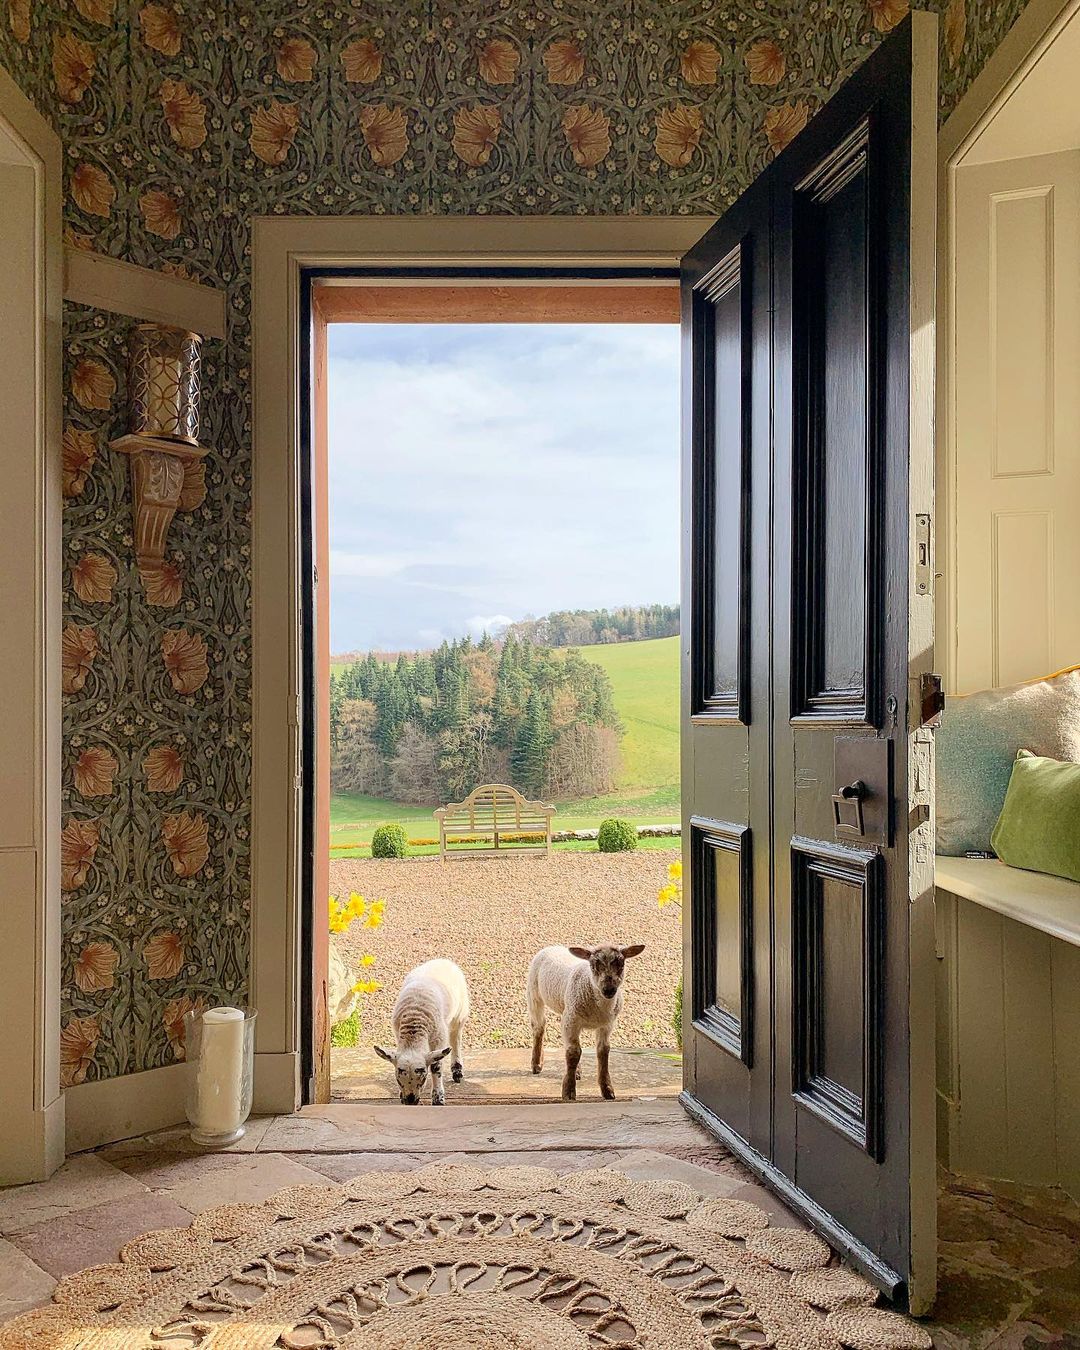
329,637 -> 679,857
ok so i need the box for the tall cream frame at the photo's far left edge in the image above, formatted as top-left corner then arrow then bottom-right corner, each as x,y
0,69 -> 65,1184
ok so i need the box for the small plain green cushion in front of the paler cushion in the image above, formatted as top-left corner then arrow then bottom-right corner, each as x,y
990,751 -> 1080,882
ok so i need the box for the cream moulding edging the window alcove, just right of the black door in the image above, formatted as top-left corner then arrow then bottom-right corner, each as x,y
936,0 -> 1080,690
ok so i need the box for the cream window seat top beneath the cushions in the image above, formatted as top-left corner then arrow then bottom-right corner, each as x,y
934,857 -> 1080,946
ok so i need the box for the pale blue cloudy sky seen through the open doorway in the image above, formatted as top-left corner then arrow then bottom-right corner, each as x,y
329,324 -> 679,652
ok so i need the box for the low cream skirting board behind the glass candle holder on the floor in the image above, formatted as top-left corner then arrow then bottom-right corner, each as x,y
63,1053 -> 300,1153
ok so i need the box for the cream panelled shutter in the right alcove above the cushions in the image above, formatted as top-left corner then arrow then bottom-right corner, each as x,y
950,153 -> 1080,694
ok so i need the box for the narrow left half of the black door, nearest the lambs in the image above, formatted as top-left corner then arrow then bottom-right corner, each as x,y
682,168 -> 771,1149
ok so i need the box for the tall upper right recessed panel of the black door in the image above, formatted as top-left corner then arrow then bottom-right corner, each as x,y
782,119 -> 879,721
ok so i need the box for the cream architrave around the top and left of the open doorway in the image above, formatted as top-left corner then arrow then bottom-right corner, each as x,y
248,216 -> 714,1112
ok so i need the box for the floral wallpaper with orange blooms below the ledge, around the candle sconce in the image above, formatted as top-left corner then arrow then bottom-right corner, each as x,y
61,305 -> 250,1085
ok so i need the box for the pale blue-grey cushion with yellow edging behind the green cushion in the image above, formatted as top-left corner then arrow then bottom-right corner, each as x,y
936,667 -> 1080,857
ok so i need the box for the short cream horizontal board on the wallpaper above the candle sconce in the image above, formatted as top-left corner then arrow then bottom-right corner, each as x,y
63,246 -> 225,338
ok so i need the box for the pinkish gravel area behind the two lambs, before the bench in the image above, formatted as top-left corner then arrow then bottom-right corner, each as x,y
329,849 -> 680,1048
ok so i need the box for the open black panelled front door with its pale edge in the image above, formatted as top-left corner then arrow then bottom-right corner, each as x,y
683,14 -> 937,1308
